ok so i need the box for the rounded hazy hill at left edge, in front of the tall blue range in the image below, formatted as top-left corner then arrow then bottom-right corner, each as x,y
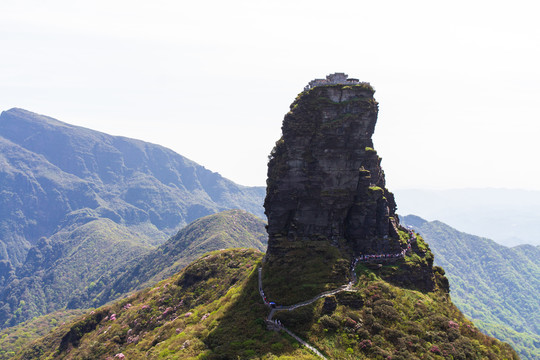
0,219 -> 149,327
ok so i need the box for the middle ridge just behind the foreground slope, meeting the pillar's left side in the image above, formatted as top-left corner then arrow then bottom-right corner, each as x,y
70,210 -> 267,307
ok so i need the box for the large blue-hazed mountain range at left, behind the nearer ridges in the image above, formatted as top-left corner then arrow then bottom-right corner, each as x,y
0,109 -> 265,328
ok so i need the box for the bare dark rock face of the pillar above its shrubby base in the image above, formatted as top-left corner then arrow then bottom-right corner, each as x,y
264,74 -> 400,259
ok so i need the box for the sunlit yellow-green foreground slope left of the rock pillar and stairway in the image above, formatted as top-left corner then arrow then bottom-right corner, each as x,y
14,249 -> 309,359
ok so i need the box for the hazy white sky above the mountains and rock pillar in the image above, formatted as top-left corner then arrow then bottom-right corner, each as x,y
0,0 -> 540,190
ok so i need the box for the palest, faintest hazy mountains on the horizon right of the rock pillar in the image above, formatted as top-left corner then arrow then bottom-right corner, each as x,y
394,189 -> 540,246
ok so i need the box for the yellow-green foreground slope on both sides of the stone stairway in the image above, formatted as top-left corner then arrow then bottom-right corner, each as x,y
15,249 -> 517,360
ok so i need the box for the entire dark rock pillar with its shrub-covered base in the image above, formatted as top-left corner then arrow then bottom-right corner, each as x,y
264,74 -> 435,302
